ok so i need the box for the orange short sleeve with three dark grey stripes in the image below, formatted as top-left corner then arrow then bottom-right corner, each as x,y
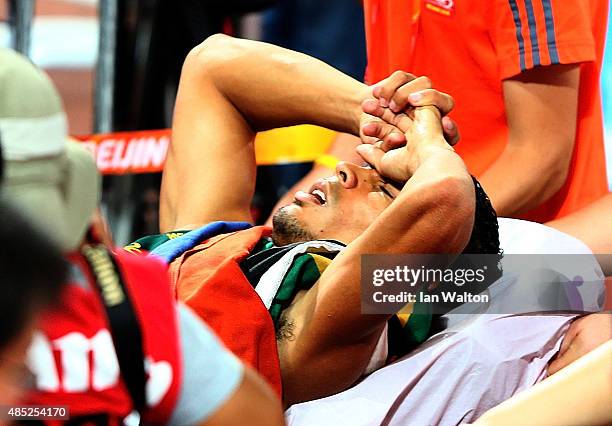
488,0 -> 595,80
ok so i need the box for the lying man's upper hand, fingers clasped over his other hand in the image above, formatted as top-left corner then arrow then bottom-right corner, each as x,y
360,71 -> 459,151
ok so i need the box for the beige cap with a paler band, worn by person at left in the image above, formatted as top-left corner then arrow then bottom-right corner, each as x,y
0,49 -> 100,250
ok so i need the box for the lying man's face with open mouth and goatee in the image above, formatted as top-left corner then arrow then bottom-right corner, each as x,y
272,162 -> 399,245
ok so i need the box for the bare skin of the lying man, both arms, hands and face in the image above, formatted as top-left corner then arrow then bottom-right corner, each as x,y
160,36 -> 475,405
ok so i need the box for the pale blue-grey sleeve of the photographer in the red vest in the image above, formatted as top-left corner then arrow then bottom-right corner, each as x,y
168,304 -> 244,426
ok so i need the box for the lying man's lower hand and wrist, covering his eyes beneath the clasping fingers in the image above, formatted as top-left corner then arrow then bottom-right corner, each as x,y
357,106 -> 453,183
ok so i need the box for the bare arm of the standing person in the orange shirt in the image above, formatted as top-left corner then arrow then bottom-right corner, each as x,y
473,64 -> 580,216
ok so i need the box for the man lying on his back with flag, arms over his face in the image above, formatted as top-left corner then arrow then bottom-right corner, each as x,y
129,36 -> 608,405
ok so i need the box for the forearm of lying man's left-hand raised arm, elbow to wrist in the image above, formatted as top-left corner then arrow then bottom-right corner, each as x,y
188,35 -> 367,135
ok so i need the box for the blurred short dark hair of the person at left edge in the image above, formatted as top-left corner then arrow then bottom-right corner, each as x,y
0,199 -> 68,349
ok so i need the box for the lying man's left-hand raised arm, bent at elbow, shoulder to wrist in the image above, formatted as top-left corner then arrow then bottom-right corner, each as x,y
160,35 -> 368,231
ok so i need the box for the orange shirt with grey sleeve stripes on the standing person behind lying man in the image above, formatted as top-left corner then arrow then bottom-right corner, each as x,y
364,0 -> 608,222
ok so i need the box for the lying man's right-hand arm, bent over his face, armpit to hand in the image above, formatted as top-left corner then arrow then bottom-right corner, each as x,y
278,107 -> 475,404
